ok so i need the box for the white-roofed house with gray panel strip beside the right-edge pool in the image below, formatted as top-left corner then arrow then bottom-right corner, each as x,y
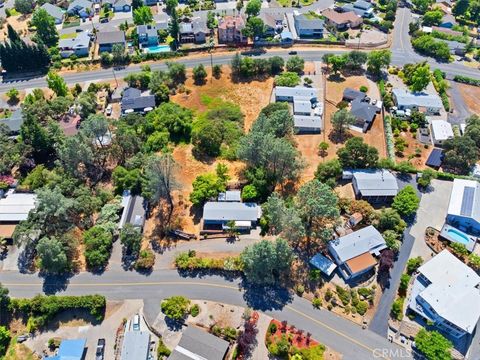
446,179 -> 480,235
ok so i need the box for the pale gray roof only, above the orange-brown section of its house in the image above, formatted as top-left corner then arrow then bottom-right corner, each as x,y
328,225 -> 387,263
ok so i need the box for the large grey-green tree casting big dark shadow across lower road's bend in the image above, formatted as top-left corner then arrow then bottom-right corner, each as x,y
240,238 -> 293,286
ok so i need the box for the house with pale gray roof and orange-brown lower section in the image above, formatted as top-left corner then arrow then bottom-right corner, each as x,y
328,225 -> 387,280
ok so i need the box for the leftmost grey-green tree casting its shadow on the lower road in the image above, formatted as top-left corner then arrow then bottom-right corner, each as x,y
36,237 -> 69,274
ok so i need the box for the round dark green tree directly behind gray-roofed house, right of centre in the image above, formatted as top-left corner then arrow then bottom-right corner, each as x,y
337,137 -> 378,169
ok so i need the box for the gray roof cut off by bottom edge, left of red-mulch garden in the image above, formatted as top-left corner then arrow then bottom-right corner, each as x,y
168,325 -> 229,360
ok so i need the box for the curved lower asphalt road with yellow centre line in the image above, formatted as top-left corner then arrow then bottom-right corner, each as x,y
1,270 -> 409,360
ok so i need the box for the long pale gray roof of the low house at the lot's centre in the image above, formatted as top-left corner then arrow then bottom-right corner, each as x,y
203,201 -> 261,221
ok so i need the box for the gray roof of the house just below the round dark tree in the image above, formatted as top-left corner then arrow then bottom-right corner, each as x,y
352,169 -> 398,196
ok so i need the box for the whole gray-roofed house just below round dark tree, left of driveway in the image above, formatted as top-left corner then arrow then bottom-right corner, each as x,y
343,169 -> 398,202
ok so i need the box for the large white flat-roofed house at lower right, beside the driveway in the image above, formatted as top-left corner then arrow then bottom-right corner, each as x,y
408,250 -> 480,339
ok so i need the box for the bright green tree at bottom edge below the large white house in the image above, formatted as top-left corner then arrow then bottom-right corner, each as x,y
415,328 -> 453,360
